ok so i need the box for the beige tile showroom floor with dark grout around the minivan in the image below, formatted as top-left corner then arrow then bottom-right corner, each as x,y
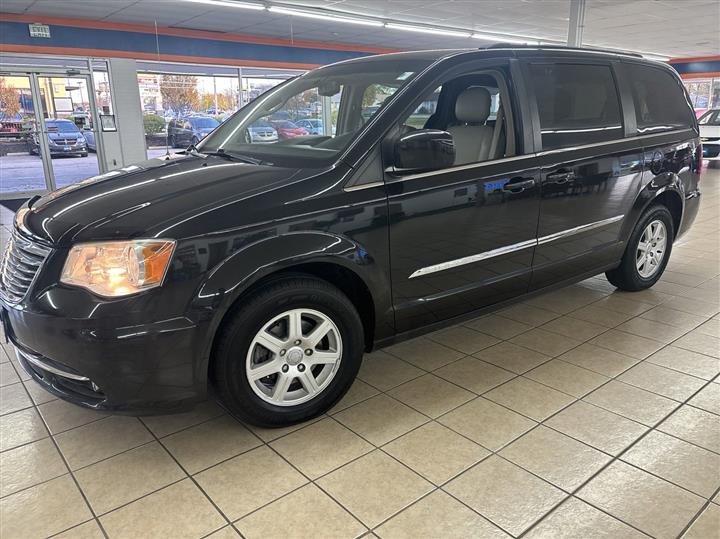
0,170 -> 720,539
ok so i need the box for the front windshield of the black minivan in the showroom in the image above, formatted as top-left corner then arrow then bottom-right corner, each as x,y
198,53 -> 436,167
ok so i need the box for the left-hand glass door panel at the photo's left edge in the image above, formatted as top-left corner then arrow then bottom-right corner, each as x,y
0,73 -> 50,199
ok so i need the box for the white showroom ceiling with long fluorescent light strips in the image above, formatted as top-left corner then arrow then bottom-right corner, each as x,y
0,0 -> 720,57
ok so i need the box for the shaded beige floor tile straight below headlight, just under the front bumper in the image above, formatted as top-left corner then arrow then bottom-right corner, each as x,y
55,416 -> 153,470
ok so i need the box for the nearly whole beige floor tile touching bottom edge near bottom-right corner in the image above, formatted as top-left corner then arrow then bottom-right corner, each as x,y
578,461 -> 704,539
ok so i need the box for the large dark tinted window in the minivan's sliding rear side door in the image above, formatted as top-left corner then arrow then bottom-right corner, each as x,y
530,64 -> 623,150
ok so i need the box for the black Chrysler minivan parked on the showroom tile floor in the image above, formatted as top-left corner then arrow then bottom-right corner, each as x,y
0,46 -> 702,425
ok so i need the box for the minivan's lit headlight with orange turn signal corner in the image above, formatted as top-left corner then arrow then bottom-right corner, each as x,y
60,240 -> 175,297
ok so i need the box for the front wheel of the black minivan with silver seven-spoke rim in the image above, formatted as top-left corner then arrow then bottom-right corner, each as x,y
210,276 -> 365,427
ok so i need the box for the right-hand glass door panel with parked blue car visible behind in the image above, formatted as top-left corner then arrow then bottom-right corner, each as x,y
37,75 -> 100,189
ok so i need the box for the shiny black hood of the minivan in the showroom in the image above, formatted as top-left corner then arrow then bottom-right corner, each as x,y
25,154 -> 317,246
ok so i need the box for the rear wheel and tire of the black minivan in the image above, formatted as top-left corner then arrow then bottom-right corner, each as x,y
605,204 -> 675,292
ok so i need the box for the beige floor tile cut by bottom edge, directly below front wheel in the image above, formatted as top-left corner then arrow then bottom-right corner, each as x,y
236,484 -> 367,539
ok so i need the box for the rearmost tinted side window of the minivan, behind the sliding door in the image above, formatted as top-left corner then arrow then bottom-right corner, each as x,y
625,64 -> 694,133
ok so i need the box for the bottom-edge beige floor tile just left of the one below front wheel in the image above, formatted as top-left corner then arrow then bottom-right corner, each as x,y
100,479 -> 227,539
